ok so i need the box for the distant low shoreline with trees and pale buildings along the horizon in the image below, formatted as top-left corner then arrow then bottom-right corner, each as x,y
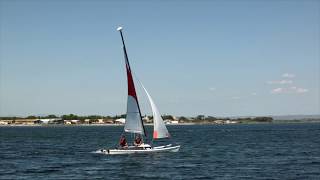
0,114 -> 320,127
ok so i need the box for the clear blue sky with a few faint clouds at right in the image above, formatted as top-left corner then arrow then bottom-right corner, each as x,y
0,0 -> 320,116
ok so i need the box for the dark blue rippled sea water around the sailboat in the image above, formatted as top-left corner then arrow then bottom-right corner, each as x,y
0,123 -> 320,179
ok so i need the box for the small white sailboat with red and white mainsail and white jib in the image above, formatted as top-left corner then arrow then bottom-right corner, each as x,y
100,27 -> 180,154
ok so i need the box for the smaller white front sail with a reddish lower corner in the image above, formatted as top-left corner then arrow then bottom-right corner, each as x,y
140,82 -> 170,139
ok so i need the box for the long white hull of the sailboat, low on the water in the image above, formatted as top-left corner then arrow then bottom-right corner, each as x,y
97,144 -> 180,154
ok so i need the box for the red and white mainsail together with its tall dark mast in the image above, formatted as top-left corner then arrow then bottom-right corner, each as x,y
117,27 -> 147,136
